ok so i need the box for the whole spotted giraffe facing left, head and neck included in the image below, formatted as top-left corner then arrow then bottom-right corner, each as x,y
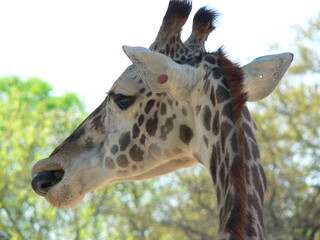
31,0 -> 293,240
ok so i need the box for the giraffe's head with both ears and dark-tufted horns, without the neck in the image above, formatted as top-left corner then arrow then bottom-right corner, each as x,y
32,1 -> 292,207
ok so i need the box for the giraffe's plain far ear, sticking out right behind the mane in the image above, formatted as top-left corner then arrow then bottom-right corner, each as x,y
242,53 -> 293,102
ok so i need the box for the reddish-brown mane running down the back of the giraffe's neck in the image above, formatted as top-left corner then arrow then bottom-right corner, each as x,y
218,48 -> 248,237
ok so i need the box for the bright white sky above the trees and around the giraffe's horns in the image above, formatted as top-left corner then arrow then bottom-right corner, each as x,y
0,0 -> 320,112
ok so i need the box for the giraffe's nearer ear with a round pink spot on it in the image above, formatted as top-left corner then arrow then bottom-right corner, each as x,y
122,46 -> 197,100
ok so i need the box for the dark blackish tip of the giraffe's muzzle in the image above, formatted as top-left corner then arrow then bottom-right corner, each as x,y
31,170 -> 64,197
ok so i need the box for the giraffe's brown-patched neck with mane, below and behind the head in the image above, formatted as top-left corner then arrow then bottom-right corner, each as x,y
192,54 -> 266,239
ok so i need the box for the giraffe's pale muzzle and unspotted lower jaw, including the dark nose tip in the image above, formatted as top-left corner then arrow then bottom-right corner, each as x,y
32,156 -> 198,208
